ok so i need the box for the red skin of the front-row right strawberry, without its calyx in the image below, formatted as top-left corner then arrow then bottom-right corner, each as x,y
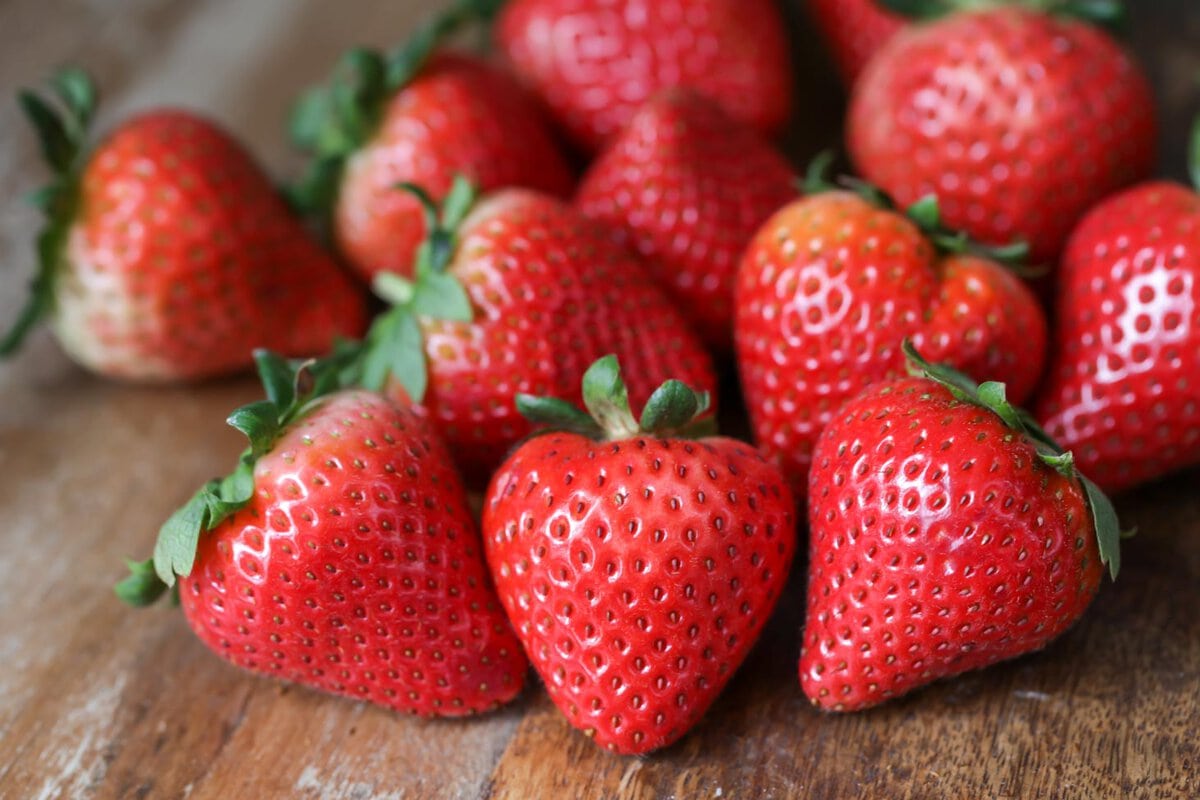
800,378 -> 1103,711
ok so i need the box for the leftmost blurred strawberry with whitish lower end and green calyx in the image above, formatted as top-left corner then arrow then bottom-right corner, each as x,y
0,68 -> 366,380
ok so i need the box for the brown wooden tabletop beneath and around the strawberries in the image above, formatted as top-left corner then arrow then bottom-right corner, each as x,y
0,0 -> 1200,800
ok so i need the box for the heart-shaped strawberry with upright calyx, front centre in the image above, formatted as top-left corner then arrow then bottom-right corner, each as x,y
484,356 -> 796,753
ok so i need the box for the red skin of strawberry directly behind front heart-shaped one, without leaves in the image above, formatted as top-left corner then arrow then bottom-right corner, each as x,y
390,190 -> 716,482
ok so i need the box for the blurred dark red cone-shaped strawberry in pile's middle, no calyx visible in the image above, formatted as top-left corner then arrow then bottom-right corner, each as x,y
575,90 -> 796,350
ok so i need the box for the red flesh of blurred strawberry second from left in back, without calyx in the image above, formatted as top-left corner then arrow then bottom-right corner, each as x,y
334,53 -> 574,279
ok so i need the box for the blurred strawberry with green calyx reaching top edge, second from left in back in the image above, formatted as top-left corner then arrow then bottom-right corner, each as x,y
293,0 -> 572,279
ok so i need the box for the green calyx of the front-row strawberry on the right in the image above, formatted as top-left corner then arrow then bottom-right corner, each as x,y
902,339 -> 1133,581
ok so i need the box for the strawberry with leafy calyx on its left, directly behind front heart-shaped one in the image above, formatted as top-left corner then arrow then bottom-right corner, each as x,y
343,181 -> 715,481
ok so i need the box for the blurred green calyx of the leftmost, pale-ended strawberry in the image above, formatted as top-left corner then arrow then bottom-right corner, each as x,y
0,67 -> 98,357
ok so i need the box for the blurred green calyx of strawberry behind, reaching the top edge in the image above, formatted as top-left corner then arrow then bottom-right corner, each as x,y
286,0 -> 503,217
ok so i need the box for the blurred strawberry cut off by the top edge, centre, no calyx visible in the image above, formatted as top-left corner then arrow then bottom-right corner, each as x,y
496,0 -> 792,150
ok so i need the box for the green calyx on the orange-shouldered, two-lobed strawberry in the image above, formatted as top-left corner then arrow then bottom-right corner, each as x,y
800,150 -> 1046,278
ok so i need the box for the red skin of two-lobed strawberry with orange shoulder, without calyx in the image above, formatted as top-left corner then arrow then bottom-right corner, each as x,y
734,192 -> 1046,497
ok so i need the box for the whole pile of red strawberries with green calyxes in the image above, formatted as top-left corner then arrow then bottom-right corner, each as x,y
7,0 -> 1200,754
